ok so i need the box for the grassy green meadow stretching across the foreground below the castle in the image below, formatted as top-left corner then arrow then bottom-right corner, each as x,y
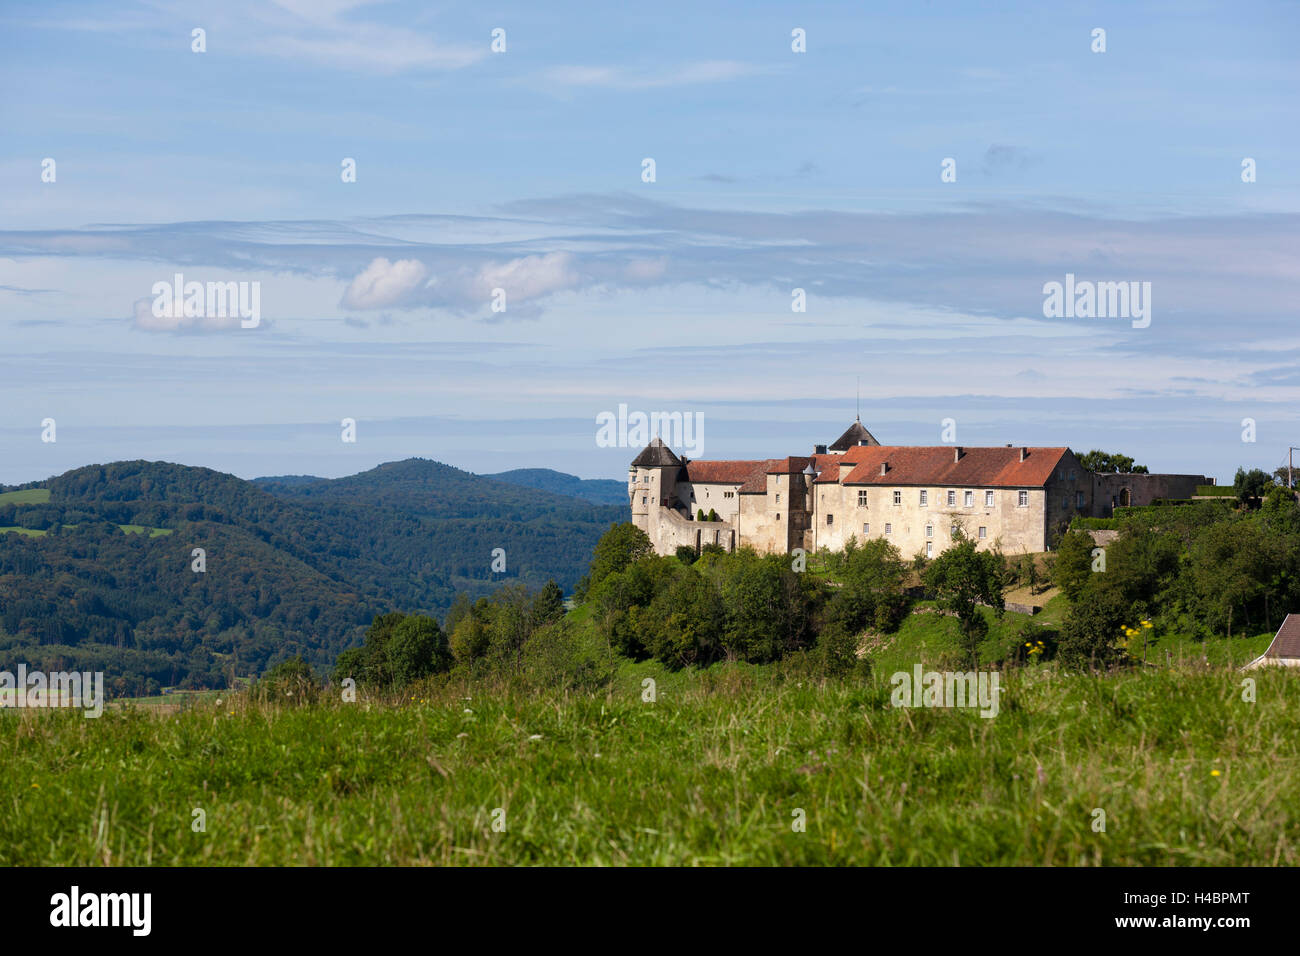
0,621 -> 1300,866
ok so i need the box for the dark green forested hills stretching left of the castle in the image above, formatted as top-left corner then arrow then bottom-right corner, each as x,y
0,459 -> 628,693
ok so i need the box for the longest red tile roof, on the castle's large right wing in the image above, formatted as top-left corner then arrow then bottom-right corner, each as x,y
818,445 -> 1069,488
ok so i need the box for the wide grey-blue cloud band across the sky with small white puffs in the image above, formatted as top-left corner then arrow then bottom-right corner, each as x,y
0,194 -> 1300,332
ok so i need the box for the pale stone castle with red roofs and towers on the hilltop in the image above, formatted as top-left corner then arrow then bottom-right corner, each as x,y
628,419 -> 1212,557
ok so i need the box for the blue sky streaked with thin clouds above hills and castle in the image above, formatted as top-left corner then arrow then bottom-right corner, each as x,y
0,0 -> 1300,484
